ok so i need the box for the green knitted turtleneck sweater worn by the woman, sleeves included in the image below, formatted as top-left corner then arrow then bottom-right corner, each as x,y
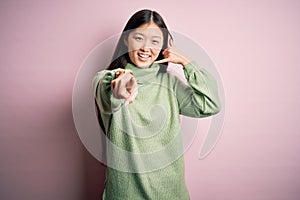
93,62 -> 220,200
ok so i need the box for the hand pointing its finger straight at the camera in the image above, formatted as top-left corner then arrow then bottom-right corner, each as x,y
111,70 -> 138,105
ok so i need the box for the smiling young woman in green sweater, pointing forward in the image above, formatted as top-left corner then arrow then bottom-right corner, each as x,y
93,10 -> 220,200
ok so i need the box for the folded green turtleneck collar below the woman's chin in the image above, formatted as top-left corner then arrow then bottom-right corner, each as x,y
125,63 -> 160,83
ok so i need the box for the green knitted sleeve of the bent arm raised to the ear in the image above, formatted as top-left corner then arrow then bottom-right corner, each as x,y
175,62 -> 220,117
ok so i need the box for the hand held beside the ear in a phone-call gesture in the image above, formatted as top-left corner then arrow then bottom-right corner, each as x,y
155,40 -> 191,67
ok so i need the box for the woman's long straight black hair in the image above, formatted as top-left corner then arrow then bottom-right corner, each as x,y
107,9 -> 173,72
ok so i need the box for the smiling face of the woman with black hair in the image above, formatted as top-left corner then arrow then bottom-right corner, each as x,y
125,22 -> 164,68
